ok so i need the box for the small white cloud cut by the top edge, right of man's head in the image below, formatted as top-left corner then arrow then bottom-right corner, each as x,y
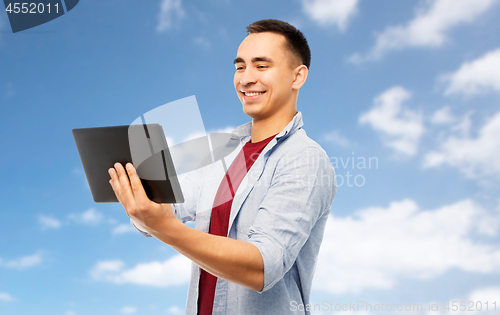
302,0 -> 359,31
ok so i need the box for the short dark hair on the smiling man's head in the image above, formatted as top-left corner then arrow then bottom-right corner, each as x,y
247,19 -> 311,69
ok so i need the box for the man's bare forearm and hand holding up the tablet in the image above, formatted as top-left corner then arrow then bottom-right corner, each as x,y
109,163 -> 264,291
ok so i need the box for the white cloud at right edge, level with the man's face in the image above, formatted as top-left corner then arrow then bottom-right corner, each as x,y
441,49 -> 500,95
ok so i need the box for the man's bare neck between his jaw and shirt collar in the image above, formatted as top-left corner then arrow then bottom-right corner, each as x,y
251,108 -> 297,143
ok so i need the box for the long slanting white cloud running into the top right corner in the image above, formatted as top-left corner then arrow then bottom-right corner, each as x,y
350,0 -> 497,62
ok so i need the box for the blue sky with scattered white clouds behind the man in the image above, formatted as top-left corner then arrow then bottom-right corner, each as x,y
0,0 -> 500,315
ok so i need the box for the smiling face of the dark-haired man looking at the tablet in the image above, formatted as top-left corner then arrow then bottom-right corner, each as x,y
234,32 -> 295,120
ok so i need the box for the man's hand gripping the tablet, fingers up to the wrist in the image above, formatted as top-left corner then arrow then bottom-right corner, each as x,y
109,163 -> 178,238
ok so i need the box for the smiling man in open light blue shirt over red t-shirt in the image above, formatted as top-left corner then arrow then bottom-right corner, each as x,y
109,20 -> 336,315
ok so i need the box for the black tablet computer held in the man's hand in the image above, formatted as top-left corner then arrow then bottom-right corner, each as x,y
72,124 -> 184,203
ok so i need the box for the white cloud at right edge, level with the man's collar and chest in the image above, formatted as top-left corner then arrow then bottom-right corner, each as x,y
423,112 -> 500,178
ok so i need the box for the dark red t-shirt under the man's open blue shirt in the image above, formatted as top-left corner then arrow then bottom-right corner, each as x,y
198,135 -> 276,315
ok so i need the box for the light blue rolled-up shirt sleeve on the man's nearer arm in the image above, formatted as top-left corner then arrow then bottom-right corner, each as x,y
248,147 -> 336,292
